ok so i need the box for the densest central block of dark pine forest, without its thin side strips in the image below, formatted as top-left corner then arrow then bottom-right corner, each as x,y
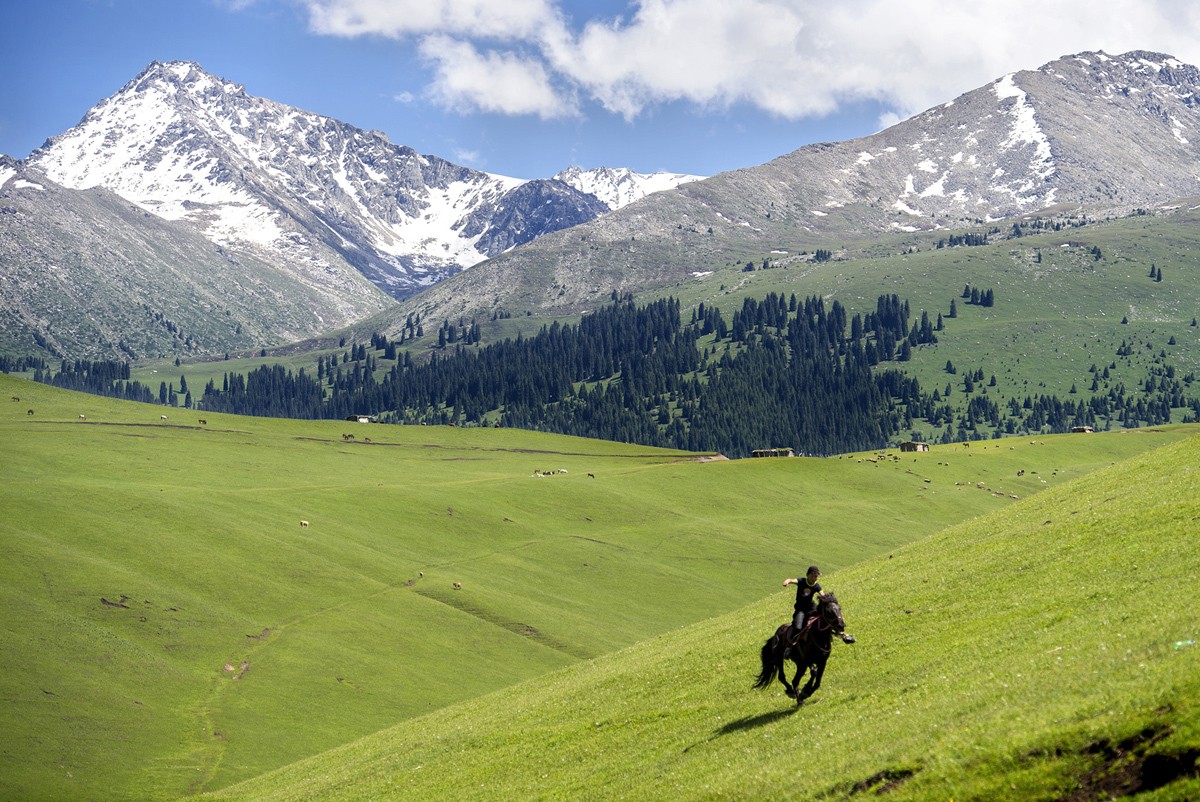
196,294 -> 912,456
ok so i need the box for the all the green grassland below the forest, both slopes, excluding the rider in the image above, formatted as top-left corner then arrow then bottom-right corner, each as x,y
0,376 -> 1200,800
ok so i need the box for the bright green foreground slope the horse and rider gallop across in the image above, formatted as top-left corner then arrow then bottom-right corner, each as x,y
214,437 -> 1200,801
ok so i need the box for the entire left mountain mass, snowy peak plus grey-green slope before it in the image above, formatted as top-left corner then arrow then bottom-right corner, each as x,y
0,61 -> 690,359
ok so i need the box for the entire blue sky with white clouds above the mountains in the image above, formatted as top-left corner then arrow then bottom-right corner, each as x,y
0,0 -> 1200,178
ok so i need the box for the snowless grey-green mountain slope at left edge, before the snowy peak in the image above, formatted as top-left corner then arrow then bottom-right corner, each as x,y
0,156 -> 394,359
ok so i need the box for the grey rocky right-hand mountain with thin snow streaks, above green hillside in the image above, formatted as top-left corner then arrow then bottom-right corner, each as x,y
400,50 -> 1200,326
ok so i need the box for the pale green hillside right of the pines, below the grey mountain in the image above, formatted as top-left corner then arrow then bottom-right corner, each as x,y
667,204 -> 1200,438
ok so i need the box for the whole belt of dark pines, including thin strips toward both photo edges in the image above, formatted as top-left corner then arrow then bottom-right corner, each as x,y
28,286 -> 1200,457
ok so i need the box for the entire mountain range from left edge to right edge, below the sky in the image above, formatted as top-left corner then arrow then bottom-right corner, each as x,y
0,52 -> 1200,357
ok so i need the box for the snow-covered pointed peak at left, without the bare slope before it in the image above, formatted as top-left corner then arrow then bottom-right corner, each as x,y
29,61 -> 608,298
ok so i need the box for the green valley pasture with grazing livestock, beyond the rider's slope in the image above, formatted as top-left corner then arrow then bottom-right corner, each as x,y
0,376 -> 1194,800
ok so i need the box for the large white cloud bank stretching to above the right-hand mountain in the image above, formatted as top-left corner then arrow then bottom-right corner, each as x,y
306,0 -> 1200,122
